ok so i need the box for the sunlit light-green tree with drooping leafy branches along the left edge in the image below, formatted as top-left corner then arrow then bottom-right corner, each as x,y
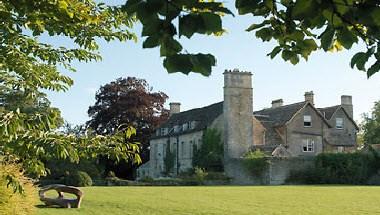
0,0 -> 140,191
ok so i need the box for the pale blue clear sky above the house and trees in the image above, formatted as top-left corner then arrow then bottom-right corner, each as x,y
46,4 -> 380,125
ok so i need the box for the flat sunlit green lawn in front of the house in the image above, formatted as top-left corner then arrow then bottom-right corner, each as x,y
37,186 -> 380,215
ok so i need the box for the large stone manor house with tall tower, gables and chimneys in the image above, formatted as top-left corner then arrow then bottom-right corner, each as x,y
138,69 -> 359,178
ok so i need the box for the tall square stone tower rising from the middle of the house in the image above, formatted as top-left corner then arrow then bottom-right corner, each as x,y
223,69 -> 253,162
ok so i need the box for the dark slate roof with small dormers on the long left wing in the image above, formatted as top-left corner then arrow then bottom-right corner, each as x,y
152,102 -> 223,139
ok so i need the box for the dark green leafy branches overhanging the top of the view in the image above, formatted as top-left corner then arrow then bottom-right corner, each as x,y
123,0 -> 380,77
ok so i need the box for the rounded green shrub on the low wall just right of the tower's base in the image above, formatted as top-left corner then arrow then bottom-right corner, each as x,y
243,150 -> 269,177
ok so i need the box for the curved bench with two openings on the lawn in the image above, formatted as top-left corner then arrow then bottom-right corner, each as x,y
38,184 -> 84,208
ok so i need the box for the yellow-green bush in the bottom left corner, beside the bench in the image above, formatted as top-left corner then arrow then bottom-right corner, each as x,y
0,164 -> 37,215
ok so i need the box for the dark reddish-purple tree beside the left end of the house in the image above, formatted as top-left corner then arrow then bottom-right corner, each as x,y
87,77 -> 169,178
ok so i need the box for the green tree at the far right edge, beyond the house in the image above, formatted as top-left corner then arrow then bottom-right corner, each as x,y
361,101 -> 380,144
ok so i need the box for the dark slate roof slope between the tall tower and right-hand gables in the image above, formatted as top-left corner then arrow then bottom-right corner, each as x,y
253,102 -> 306,127
